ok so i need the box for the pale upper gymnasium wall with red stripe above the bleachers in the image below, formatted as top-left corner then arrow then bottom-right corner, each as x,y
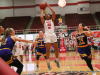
0,0 -> 100,19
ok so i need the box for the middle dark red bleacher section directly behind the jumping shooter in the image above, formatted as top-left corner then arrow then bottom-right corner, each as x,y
30,14 -> 60,29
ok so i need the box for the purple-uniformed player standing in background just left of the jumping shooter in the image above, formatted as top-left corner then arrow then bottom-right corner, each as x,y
34,31 -> 46,71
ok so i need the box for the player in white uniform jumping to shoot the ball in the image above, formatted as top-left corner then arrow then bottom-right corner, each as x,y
40,3 -> 60,70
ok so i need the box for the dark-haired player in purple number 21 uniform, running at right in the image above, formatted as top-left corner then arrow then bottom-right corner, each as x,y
76,23 -> 96,75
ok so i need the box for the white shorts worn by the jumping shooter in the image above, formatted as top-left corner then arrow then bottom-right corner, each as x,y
44,33 -> 57,43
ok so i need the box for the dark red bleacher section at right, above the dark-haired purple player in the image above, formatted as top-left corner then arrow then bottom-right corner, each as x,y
65,13 -> 96,27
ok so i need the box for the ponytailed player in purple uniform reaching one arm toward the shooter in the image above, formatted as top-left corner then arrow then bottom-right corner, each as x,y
0,27 -> 38,75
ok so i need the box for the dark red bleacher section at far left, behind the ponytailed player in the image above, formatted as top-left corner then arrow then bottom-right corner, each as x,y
0,16 -> 31,30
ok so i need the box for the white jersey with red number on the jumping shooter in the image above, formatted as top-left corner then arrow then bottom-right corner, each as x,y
44,20 -> 54,33
